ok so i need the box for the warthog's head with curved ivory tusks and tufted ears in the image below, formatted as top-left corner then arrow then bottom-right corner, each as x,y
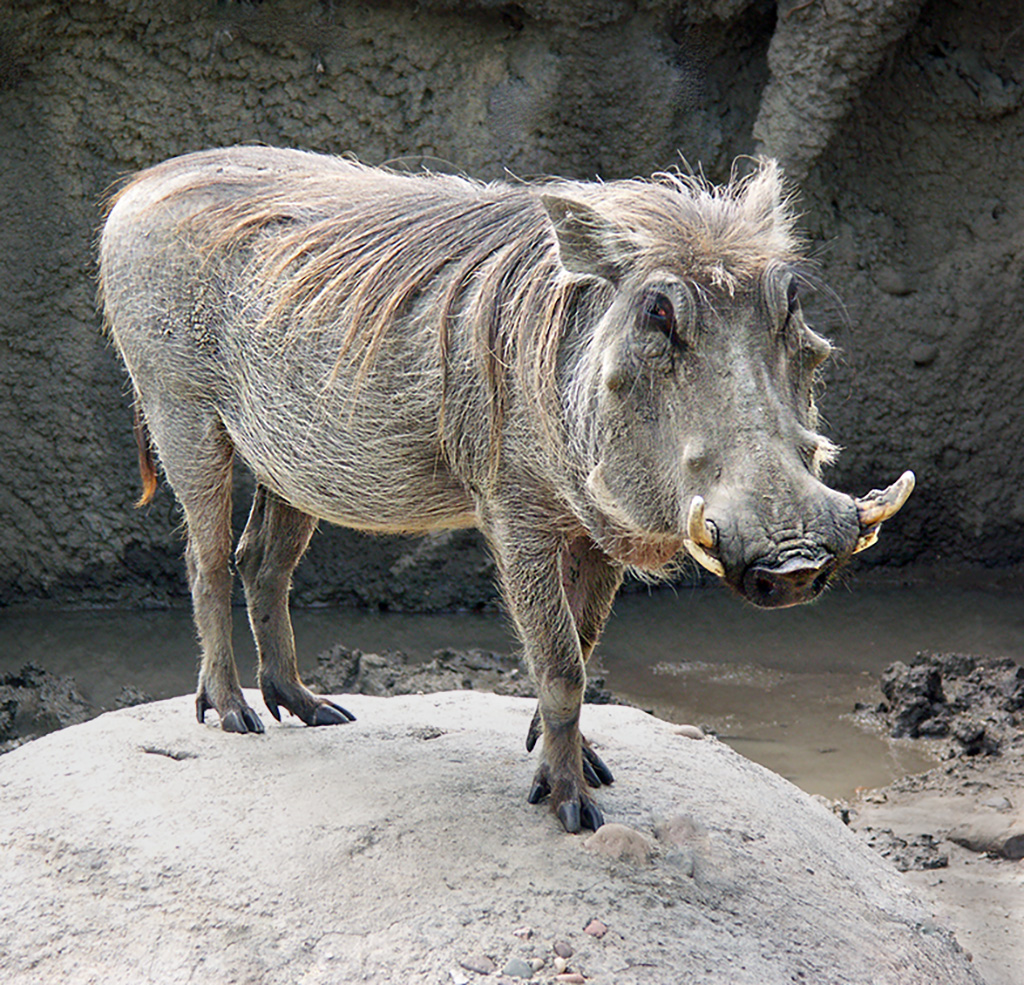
545,163 -> 913,607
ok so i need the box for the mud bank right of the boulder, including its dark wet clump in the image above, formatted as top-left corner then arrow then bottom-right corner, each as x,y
841,653 -> 1024,985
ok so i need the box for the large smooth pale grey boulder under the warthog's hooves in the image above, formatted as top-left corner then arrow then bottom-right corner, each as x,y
0,691 -> 981,985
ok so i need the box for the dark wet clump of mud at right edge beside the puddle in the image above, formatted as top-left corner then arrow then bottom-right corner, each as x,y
856,650 -> 1024,756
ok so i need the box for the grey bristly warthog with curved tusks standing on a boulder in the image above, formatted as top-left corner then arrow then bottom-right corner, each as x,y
100,147 -> 913,831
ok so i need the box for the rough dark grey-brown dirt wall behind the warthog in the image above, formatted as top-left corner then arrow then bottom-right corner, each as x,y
0,0 -> 1024,608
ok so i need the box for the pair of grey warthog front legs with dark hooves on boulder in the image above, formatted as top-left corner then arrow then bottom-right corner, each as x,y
493,518 -> 622,832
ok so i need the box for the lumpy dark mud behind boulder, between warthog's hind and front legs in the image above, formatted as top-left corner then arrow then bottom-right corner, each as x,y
308,645 -> 624,704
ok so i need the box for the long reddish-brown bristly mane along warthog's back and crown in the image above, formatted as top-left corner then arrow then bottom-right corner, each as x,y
140,148 -> 800,464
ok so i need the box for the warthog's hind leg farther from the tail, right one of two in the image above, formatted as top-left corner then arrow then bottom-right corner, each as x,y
236,485 -> 355,725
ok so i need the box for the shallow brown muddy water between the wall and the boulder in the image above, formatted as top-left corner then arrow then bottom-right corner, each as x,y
0,585 -> 1024,797
